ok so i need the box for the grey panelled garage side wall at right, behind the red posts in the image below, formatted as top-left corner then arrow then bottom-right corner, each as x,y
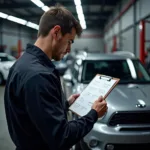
104,0 -> 150,57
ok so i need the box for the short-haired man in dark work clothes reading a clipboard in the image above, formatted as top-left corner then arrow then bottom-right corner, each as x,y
5,6 -> 107,150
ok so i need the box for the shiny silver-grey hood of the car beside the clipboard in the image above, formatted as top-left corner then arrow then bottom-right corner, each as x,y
79,84 -> 150,122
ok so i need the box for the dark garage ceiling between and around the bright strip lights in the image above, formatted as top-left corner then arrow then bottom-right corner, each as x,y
0,0 -> 119,30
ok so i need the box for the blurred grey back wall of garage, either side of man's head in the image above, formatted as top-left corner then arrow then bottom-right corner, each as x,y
0,20 -> 104,53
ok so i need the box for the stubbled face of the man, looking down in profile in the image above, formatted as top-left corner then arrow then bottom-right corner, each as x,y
52,28 -> 76,61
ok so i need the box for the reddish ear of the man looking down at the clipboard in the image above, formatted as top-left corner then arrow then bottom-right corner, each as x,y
52,25 -> 62,40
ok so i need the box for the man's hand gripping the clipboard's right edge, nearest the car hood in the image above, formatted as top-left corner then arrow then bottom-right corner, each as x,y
92,96 -> 108,118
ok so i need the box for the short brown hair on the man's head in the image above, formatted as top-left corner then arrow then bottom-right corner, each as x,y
38,5 -> 82,37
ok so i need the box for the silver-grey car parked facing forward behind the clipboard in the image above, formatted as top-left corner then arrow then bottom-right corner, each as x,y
63,53 -> 150,150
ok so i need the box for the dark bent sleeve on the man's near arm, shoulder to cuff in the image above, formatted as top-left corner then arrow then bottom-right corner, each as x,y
24,75 -> 98,150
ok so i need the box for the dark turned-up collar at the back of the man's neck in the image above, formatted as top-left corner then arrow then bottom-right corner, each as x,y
26,44 -> 55,69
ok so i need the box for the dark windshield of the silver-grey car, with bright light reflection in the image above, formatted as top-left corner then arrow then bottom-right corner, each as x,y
82,59 -> 150,84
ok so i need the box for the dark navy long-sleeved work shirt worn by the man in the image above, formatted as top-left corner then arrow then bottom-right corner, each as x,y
4,44 -> 97,150
